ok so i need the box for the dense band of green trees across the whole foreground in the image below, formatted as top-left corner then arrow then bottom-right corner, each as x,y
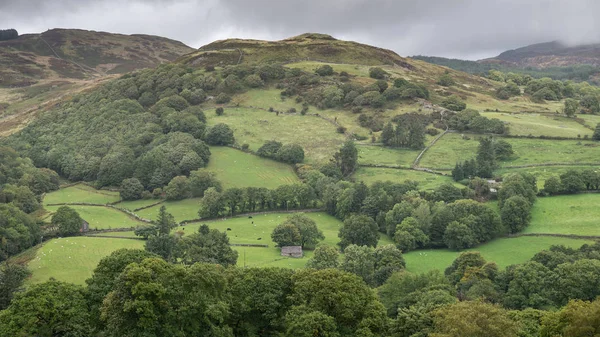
0,240 -> 600,337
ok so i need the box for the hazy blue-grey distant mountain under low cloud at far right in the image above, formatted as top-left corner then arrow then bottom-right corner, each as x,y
479,41 -> 600,69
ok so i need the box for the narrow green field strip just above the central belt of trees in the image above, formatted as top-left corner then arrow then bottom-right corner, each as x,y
353,167 -> 458,190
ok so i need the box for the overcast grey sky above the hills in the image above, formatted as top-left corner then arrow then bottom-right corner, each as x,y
0,0 -> 600,59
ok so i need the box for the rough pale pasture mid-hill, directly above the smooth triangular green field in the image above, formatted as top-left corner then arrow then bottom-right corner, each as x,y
207,108 -> 345,163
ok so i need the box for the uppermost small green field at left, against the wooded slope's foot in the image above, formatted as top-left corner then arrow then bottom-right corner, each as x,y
44,184 -> 120,205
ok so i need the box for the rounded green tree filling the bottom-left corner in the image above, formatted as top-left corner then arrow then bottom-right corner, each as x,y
0,281 -> 92,337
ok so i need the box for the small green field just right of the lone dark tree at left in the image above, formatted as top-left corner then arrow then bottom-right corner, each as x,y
45,206 -> 144,230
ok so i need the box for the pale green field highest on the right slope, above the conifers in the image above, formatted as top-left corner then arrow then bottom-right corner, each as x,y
482,112 -> 592,137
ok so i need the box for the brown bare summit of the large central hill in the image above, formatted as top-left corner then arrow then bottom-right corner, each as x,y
179,33 -> 411,69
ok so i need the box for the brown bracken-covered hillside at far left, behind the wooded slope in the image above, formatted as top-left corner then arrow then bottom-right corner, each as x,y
0,29 -> 193,136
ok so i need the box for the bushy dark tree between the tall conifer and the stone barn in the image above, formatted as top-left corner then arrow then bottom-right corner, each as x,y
181,225 -> 238,267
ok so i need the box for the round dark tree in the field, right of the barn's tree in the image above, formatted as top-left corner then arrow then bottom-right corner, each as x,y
338,215 -> 379,249
